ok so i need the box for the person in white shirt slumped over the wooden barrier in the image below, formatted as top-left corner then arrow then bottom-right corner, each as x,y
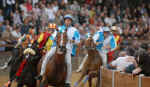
109,51 -> 137,73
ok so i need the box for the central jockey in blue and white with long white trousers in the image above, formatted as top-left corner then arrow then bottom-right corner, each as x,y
36,14 -> 80,87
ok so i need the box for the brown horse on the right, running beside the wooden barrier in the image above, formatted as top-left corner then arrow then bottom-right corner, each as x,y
74,37 -> 102,87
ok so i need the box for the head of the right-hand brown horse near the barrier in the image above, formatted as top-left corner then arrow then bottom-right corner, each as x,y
85,36 -> 96,49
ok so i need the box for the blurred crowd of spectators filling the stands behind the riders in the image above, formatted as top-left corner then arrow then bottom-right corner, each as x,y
0,0 -> 150,75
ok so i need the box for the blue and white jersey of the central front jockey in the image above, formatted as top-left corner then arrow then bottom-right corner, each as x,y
58,25 -> 80,55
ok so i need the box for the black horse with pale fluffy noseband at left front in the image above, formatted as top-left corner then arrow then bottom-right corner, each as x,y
16,45 -> 41,87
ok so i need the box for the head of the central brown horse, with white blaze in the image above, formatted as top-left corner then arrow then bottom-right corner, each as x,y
56,32 -> 67,54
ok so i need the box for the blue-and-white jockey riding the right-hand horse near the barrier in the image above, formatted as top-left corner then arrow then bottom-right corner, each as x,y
93,27 -> 116,66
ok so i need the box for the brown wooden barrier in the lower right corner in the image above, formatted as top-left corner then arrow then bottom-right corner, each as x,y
101,68 -> 150,87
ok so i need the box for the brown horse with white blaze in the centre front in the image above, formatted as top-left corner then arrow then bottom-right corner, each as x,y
37,33 -> 67,87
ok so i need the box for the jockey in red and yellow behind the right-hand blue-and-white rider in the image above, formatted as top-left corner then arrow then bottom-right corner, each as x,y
108,26 -> 121,63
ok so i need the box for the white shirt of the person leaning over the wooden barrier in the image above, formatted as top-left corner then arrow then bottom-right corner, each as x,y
111,56 -> 134,71
